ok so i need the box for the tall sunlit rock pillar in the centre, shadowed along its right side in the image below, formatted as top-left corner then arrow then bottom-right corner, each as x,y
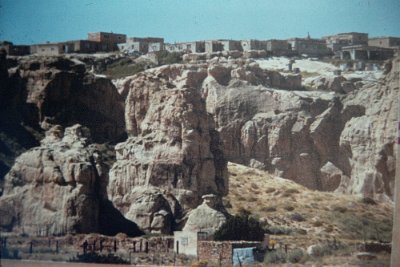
107,65 -> 228,233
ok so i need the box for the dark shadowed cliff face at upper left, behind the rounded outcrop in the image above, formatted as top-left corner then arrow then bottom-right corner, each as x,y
0,57 -> 125,186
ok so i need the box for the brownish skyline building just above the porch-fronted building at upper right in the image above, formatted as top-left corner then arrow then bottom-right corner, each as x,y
322,32 -> 368,52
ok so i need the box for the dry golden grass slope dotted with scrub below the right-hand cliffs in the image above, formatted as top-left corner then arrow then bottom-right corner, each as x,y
226,163 -> 393,249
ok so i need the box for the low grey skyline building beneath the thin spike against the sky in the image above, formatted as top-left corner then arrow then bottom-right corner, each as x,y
287,36 -> 331,57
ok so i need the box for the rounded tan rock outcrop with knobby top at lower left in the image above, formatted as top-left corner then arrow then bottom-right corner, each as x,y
0,125 -> 104,234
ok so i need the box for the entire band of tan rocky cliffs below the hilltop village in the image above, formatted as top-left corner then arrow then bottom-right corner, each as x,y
0,53 -> 400,238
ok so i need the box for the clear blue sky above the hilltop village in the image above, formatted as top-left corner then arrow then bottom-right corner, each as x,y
0,0 -> 400,44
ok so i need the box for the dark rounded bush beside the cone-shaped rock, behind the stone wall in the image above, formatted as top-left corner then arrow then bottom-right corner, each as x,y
214,214 -> 264,241
